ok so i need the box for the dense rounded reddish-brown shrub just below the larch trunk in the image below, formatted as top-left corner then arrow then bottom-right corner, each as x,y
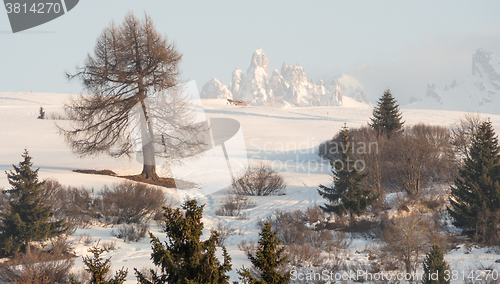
101,181 -> 166,224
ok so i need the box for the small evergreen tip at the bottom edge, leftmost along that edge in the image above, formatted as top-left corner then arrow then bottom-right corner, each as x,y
70,247 -> 127,284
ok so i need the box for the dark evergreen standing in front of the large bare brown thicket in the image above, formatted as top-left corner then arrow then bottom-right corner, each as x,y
318,126 -> 378,222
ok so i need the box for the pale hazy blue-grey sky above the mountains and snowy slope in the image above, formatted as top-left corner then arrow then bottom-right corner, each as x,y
0,0 -> 500,102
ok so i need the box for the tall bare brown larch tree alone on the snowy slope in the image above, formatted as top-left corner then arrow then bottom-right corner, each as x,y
60,13 -> 205,180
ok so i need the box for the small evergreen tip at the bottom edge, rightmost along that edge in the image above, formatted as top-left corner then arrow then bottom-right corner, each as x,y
422,245 -> 451,284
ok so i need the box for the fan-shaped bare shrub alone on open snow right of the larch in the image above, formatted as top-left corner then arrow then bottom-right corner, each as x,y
232,164 -> 286,196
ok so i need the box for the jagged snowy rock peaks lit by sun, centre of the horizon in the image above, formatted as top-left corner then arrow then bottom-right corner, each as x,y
201,49 -> 370,107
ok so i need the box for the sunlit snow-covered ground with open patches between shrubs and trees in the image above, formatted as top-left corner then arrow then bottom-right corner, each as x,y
0,93 -> 500,283
